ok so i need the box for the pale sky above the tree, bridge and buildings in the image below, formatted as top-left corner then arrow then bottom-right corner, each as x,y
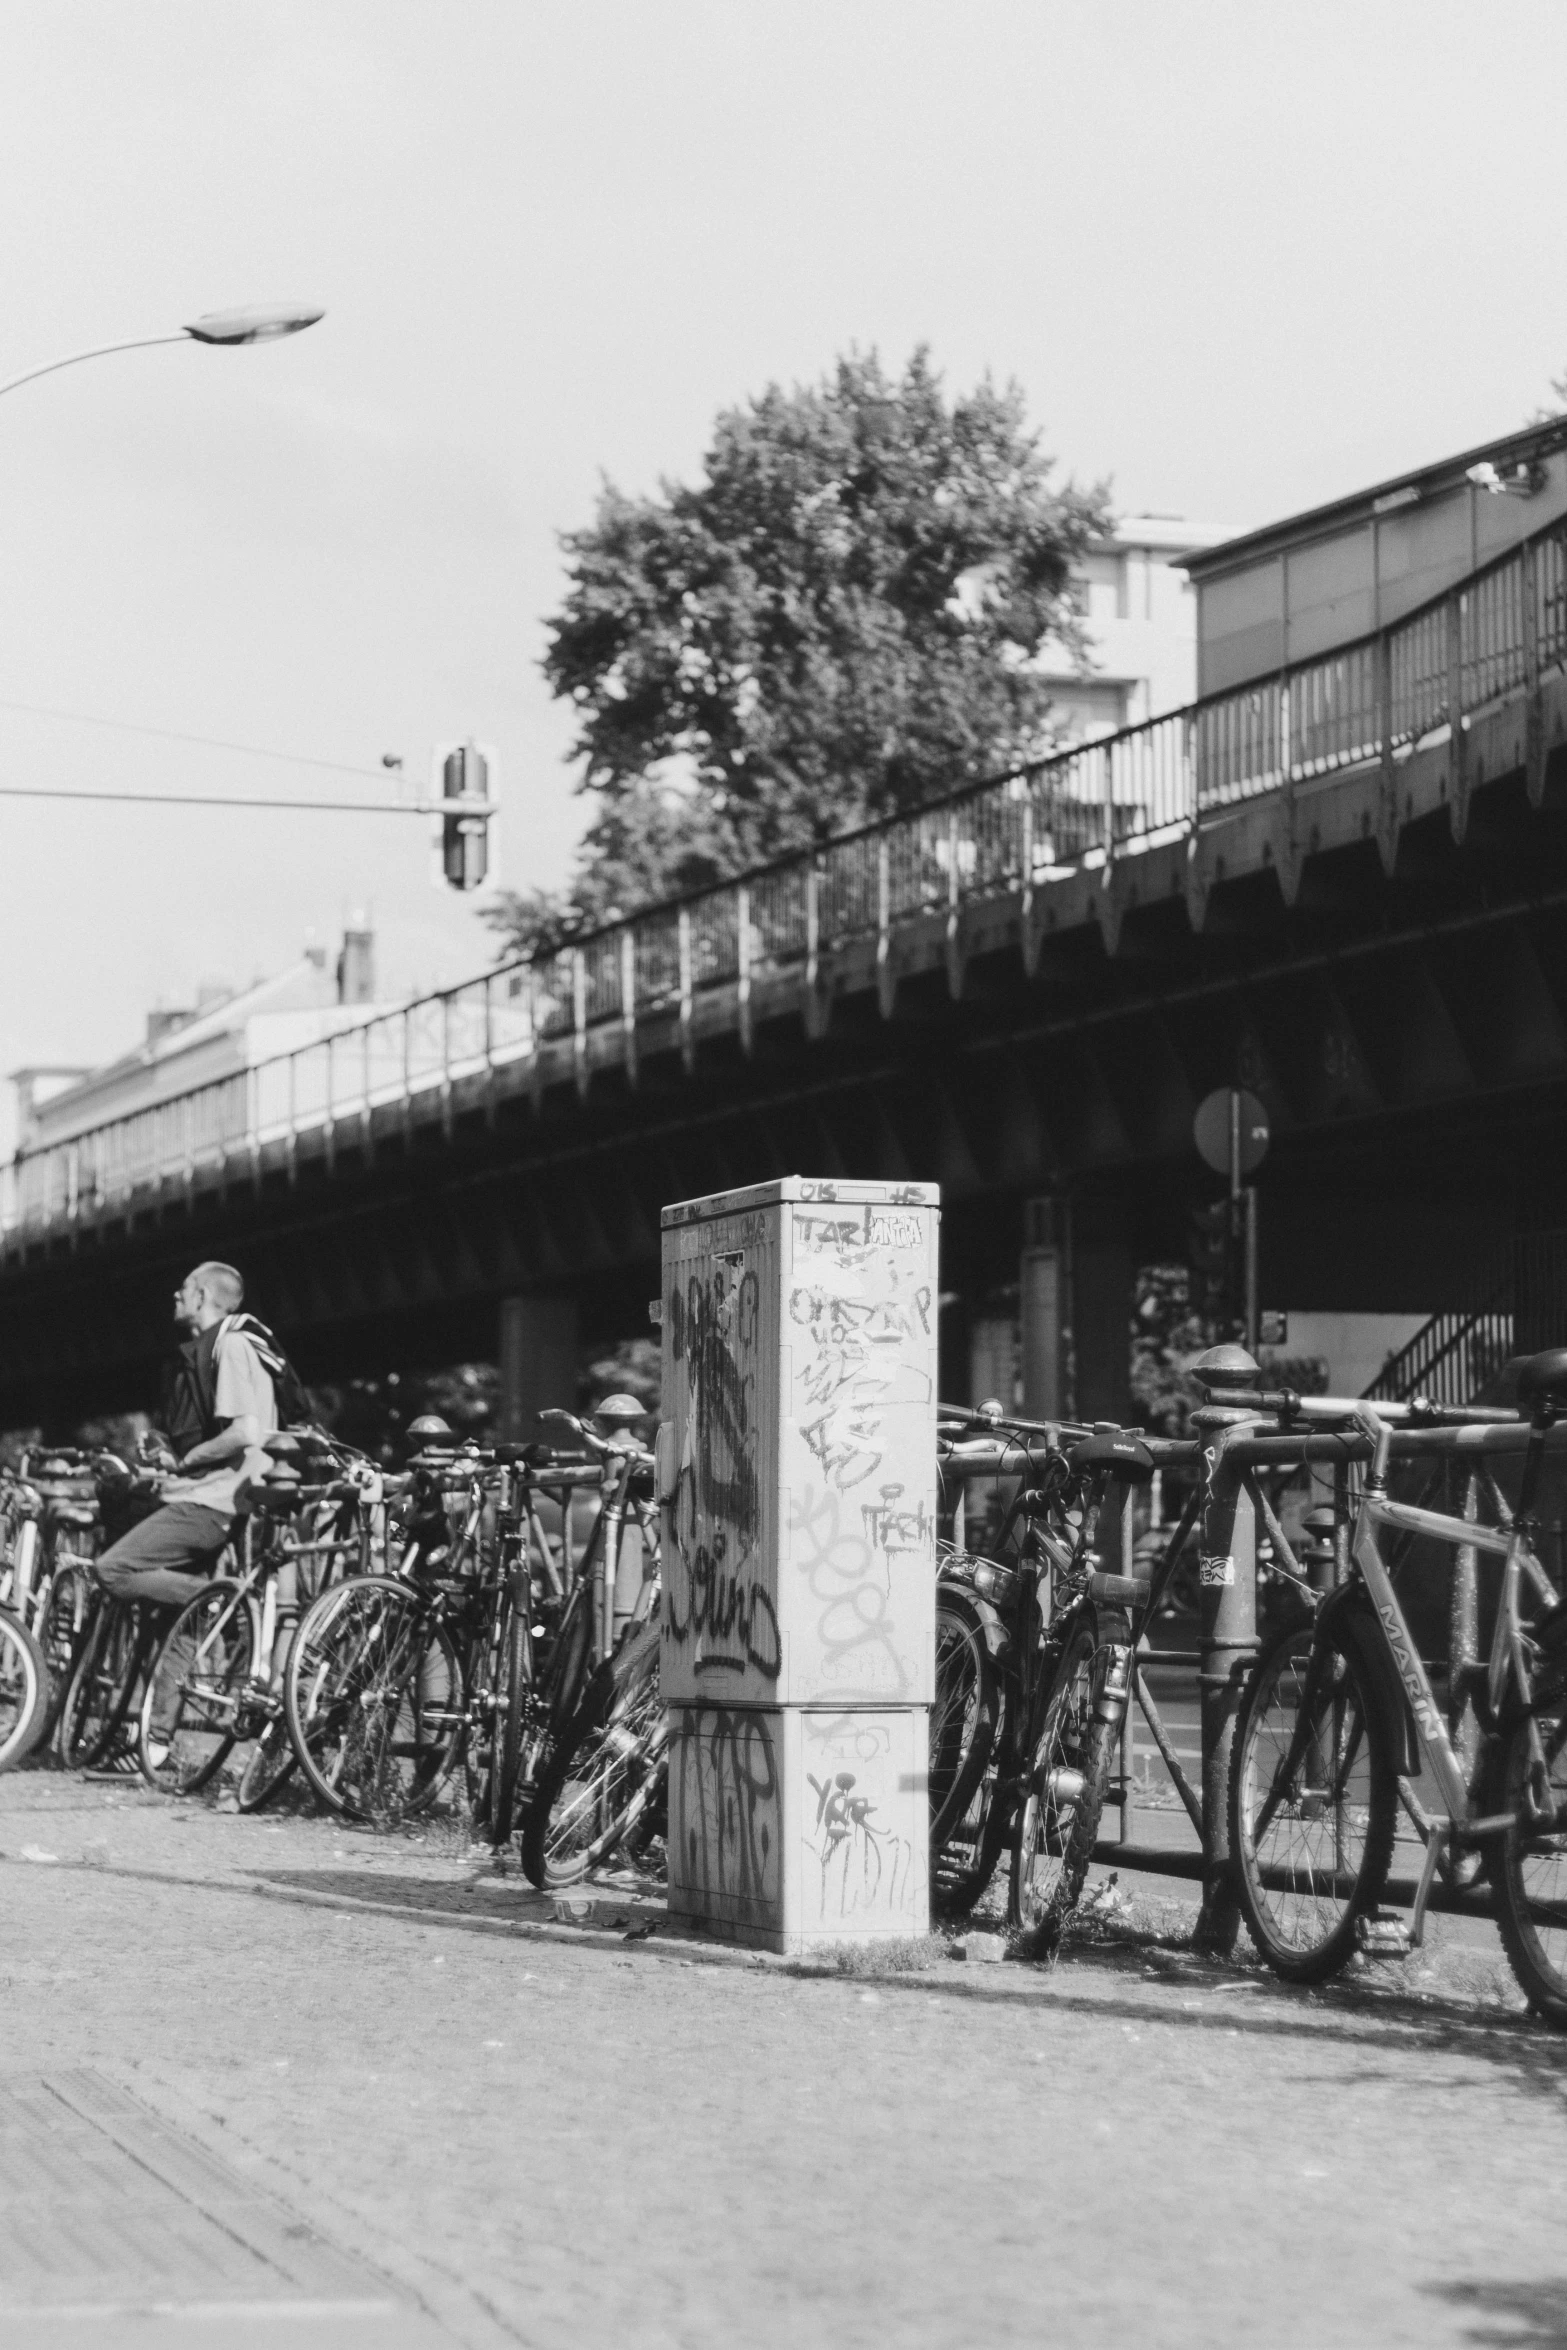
0,0 -> 1567,1149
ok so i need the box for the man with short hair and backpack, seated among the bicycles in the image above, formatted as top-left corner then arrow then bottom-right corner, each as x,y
99,1262 -> 284,1607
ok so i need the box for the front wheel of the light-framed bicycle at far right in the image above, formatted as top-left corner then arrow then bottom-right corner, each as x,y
1229,1622 -> 1398,1983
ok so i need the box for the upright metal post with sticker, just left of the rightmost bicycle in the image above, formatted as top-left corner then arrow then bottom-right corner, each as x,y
1191,1405 -> 1257,1958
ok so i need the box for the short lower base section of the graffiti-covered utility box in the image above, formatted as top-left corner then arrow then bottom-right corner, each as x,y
670,1706 -> 930,1951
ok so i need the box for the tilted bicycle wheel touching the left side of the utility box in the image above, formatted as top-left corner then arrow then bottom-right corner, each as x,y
522,1622 -> 667,1887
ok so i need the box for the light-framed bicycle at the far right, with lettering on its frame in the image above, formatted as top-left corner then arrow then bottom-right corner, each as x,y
1229,1349 -> 1567,2023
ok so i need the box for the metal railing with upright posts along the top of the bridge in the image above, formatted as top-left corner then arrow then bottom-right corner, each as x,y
0,519 -> 1567,1241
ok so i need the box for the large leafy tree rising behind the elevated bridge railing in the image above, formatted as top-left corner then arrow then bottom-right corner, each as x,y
491,350 -> 1109,947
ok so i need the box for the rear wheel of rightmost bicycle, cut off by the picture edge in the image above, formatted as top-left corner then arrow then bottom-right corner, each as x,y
1489,1685 -> 1567,2023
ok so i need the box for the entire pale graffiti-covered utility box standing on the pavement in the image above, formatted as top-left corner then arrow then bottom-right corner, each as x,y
658,1175 -> 940,1951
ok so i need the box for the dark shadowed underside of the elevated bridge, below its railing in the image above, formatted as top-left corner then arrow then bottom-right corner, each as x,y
0,738 -> 1567,1424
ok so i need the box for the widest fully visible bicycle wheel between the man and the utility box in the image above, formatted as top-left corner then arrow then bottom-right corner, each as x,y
284,1575 -> 465,1824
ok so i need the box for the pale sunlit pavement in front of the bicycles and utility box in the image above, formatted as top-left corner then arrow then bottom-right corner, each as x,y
0,1772 -> 1567,2350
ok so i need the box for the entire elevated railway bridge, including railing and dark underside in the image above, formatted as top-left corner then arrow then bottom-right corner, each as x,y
0,519 -> 1567,1424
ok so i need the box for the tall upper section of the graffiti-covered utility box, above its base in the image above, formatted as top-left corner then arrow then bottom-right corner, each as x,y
660,1175 -> 940,1706
